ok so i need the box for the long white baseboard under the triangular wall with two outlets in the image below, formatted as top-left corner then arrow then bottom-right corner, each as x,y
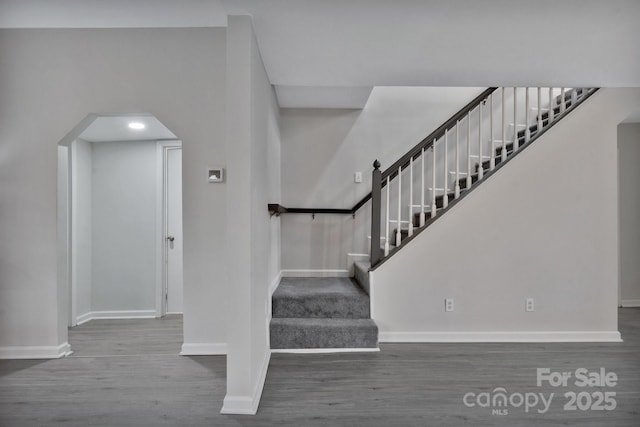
378,331 -> 622,343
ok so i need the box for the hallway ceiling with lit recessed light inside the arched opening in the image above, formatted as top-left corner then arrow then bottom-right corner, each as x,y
79,116 -> 177,142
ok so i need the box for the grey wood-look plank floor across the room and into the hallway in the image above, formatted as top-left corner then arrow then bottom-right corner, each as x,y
0,309 -> 640,427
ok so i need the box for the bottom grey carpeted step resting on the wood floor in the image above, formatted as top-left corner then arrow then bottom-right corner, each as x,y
270,318 -> 378,349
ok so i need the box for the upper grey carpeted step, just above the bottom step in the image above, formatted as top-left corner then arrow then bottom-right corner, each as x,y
272,277 -> 370,319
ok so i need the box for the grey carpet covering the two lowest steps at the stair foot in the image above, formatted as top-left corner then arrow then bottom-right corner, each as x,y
270,277 -> 378,349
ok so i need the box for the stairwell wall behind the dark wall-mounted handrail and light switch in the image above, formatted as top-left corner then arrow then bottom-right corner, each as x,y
282,87 -> 483,270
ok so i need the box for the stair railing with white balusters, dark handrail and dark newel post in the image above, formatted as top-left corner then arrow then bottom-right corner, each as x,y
371,87 -> 595,264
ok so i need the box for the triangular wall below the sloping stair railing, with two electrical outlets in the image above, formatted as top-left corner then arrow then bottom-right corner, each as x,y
370,89 -> 640,342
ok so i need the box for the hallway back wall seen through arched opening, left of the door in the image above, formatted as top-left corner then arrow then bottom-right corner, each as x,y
91,141 -> 162,311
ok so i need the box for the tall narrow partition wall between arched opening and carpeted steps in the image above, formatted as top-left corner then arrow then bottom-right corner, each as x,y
222,16 -> 280,414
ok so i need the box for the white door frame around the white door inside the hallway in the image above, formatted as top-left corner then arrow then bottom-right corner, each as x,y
156,139 -> 182,317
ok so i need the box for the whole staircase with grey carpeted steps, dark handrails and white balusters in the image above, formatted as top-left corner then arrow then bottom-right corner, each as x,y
269,88 -> 597,350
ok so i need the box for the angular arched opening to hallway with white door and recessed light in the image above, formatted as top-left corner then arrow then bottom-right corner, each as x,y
58,114 -> 183,353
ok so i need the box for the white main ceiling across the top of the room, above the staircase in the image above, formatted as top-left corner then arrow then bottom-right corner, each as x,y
0,0 -> 640,107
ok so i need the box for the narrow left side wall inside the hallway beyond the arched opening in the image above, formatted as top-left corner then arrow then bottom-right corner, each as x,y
71,139 -> 93,325
